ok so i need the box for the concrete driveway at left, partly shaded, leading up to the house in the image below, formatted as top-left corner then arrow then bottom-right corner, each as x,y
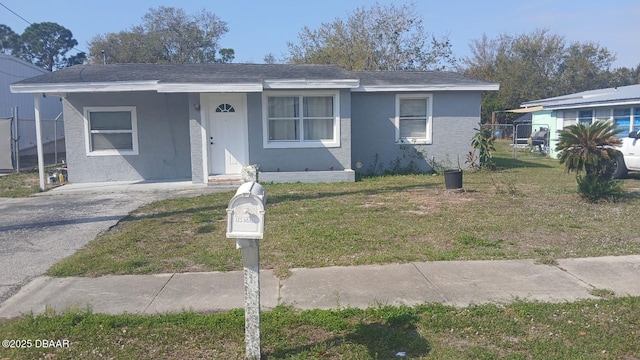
0,182 -> 237,303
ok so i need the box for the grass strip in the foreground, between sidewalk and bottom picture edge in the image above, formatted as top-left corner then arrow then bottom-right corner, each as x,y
0,297 -> 640,359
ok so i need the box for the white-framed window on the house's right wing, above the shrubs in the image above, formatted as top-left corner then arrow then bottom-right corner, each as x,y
395,95 -> 431,144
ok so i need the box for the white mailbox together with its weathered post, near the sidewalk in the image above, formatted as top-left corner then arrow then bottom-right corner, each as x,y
227,182 -> 267,360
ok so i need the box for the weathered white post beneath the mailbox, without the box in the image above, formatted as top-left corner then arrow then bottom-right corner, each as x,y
236,239 -> 260,360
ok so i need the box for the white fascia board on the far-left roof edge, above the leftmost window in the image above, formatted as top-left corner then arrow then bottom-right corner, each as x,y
10,80 -> 158,94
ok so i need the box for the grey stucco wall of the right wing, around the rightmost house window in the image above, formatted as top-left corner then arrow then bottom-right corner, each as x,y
352,91 -> 481,174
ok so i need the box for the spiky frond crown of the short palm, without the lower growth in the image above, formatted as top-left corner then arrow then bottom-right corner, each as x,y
556,121 -> 622,178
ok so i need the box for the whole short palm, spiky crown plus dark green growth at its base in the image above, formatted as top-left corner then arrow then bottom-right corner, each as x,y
556,121 -> 623,202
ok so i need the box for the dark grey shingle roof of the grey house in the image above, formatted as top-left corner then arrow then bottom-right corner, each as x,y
12,63 -> 498,92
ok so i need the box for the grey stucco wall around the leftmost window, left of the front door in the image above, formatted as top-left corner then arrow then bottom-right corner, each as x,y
64,92 -> 191,182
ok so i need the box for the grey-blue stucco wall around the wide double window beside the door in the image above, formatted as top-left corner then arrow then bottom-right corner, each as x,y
247,90 -> 351,172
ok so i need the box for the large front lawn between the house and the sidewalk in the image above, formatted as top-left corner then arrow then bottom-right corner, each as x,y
48,140 -> 640,276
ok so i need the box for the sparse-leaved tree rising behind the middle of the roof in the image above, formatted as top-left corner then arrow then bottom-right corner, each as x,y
287,3 -> 455,70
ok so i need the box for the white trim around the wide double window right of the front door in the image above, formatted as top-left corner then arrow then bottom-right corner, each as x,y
262,91 -> 340,149
